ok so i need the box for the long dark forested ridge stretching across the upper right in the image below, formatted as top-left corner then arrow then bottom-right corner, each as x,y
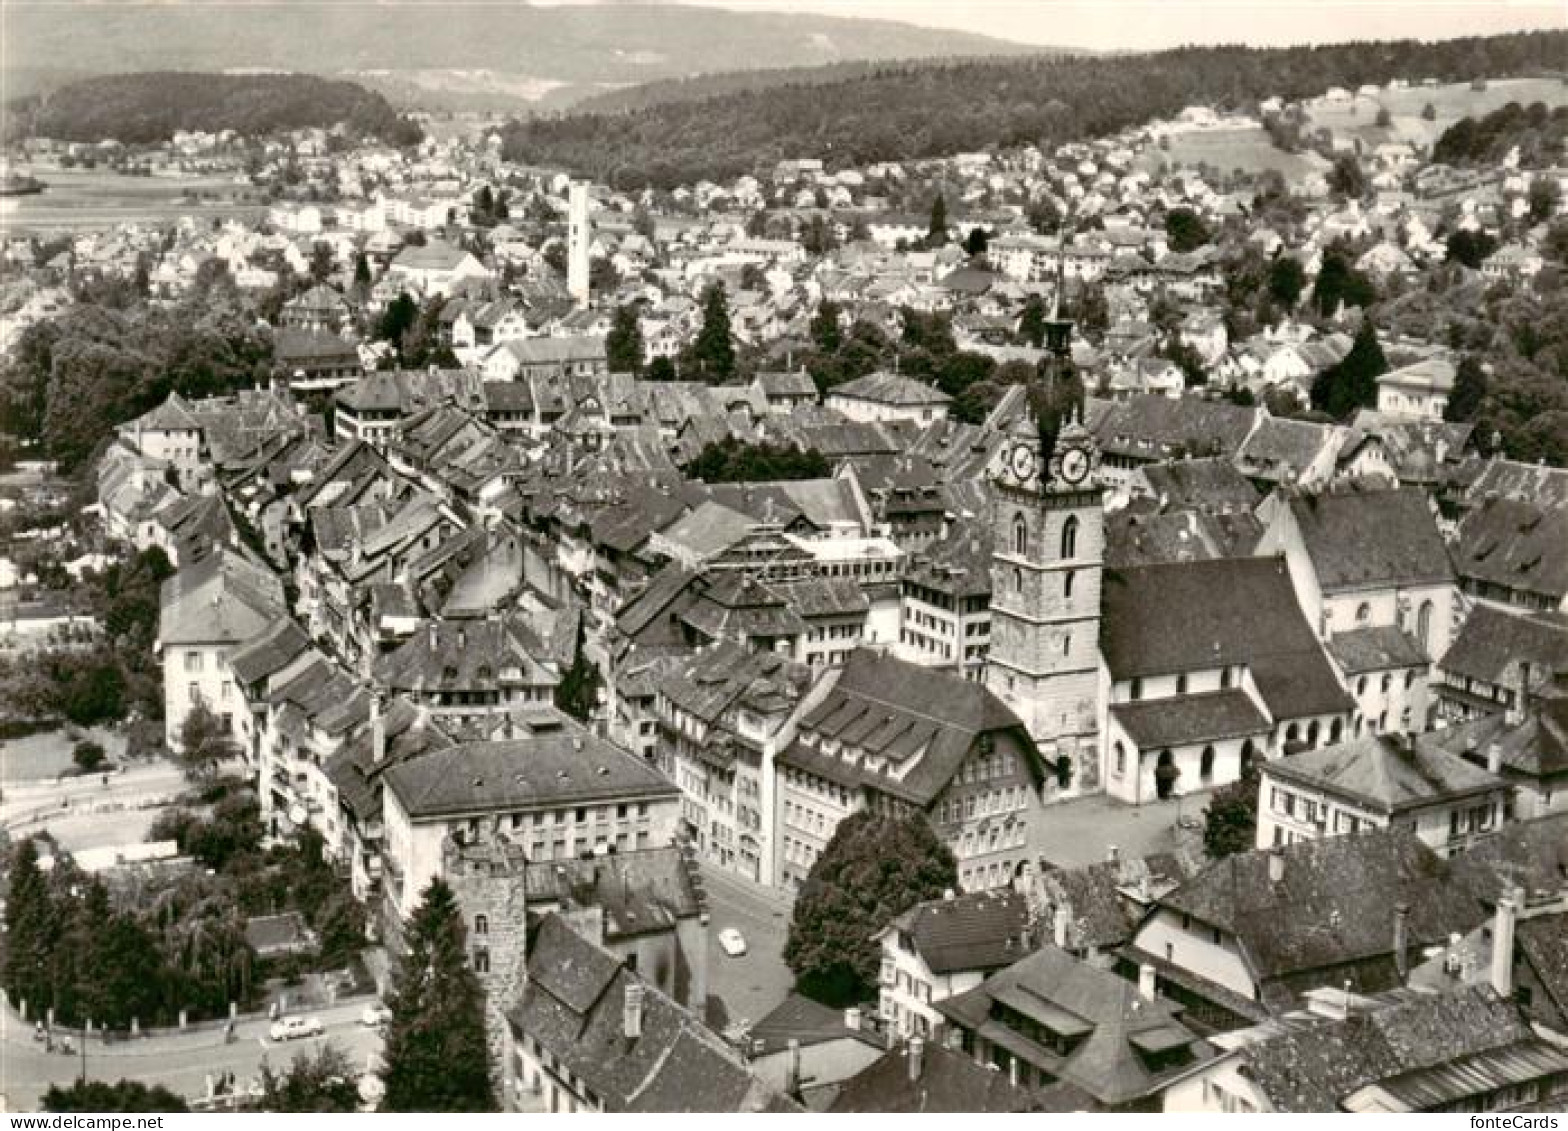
503,31 -> 1568,188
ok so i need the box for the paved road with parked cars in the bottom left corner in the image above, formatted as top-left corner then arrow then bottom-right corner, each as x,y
0,999 -> 381,1111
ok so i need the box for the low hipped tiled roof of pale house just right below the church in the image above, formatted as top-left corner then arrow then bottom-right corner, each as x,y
1264,734 -> 1505,814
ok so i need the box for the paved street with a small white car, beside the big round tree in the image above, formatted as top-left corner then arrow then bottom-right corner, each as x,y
702,866 -> 795,1029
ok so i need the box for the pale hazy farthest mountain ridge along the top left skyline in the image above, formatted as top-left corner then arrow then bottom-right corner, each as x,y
5,0 -> 1027,105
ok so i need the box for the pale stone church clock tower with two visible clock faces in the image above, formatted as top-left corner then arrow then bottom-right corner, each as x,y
986,414 -> 1105,792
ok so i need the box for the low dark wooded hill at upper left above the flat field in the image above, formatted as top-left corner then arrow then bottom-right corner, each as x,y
6,71 -> 420,144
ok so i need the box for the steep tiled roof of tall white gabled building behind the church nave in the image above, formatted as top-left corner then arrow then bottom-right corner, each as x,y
1290,488 -> 1454,593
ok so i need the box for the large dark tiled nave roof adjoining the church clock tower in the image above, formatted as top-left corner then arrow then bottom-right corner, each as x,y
1099,558 -> 1352,720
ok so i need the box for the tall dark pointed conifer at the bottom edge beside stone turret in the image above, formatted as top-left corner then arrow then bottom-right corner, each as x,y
381,878 -> 495,1112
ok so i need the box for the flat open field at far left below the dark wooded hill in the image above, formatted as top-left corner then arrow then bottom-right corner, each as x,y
0,168 -> 262,234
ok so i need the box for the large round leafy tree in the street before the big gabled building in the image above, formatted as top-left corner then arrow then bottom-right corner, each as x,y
784,811 -> 958,1006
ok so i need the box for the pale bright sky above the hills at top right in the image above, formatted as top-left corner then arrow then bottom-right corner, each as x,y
646,0 -> 1568,50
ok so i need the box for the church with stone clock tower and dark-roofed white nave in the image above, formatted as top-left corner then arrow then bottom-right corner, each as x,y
985,304 -> 1355,805
